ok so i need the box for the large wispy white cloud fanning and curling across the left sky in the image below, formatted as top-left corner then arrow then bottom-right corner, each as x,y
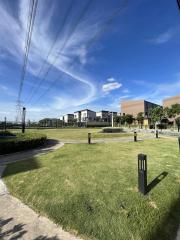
0,0 -> 120,113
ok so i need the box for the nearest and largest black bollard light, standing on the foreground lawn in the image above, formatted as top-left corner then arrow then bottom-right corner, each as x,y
138,154 -> 147,195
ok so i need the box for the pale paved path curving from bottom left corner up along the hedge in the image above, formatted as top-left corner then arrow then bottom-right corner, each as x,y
0,140 -> 80,240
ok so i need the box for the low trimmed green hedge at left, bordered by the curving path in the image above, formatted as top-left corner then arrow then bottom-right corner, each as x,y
0,133 -> 47,154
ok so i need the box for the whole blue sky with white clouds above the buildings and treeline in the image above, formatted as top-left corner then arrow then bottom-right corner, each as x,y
0,0 -> 180,120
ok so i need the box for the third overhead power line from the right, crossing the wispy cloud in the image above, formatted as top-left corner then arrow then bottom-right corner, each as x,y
26,0 -> 73,103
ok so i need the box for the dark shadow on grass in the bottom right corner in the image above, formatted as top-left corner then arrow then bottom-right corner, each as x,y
148,197 -> 180,240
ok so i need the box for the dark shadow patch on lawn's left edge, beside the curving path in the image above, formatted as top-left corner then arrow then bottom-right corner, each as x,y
3,158 -> 41,177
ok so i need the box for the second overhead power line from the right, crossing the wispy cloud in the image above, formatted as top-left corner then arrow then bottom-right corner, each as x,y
26,0 -> 93,105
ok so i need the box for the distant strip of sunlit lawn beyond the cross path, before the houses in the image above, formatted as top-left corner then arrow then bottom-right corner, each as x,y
11,128 -> 132,140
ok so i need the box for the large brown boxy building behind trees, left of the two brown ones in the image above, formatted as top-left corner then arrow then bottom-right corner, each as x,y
121,100 -> 160,118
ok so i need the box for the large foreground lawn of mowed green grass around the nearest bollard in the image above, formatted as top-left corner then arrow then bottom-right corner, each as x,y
4,139 -> 180,240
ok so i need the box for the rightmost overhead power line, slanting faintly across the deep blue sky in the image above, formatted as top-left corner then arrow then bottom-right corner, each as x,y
32,0 -> 128,104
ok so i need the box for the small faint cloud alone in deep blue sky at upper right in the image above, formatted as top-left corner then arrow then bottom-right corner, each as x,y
150,29 -> 175,44
